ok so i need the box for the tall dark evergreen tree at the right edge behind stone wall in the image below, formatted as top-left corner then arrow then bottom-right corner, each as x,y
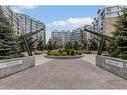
109,8 -> 127,59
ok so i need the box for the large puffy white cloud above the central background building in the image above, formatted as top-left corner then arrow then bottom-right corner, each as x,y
47,17 -> 93,29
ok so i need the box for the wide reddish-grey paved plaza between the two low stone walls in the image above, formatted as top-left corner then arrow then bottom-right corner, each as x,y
0,55 -> 127,89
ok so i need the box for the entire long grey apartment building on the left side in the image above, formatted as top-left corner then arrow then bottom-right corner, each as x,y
1,6 -> 46,44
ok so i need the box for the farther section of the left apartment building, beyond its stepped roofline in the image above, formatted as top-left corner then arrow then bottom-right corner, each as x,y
17,13 -> 46,44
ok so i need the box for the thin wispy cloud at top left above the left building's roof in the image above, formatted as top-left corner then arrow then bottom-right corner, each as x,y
11,5 -> 37,13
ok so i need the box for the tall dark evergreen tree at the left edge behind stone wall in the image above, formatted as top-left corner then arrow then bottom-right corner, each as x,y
0,6 -> 20,58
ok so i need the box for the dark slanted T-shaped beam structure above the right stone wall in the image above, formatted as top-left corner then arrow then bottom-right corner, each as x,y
84,28 -> 112,55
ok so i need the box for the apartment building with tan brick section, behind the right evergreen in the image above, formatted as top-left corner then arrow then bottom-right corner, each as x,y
92,6 -> 122,36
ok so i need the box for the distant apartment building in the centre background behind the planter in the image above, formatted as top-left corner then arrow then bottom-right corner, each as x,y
51,25 -> 91,46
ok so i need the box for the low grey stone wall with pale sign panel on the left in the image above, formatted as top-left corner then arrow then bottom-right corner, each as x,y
0,56 -> 35,78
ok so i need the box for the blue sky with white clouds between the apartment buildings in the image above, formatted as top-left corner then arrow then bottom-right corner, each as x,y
11,5 -> 104,42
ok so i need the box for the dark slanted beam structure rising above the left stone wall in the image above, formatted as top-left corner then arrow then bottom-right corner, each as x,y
18,28 -> 45,56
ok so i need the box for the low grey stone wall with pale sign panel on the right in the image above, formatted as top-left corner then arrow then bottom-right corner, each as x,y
96,55 -> 127,79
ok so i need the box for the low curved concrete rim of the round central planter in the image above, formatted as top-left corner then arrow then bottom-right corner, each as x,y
45,55 -> 84,59
